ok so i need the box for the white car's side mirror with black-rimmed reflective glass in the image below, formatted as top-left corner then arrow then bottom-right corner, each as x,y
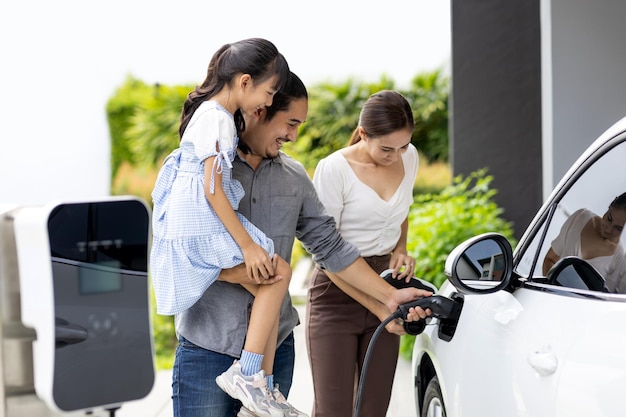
445,233 -> 513,294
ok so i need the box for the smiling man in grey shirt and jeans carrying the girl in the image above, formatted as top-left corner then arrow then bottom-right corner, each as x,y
172,74 -> 430,417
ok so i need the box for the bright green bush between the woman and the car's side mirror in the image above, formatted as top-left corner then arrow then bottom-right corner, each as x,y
400,169 -> 516,358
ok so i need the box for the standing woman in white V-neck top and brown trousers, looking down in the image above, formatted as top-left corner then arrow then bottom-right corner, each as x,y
307,90 -> 418,417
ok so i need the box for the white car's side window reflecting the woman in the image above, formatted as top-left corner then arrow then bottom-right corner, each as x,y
515,135 -> 626,289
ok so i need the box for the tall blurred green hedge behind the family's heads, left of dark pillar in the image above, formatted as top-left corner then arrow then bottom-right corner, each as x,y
107,71 -> 449,179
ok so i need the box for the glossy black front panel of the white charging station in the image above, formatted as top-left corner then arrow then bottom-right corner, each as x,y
48,200 -> 154,411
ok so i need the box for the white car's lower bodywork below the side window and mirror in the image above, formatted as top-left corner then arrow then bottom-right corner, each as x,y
414,280 -> 626,417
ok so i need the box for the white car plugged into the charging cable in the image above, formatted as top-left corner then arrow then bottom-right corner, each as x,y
412,118 -> 626,417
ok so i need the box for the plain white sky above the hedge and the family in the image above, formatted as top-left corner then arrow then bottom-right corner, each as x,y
0,0 -> 450,204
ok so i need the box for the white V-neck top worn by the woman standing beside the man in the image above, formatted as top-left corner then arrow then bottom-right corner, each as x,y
313,144 -> 419,256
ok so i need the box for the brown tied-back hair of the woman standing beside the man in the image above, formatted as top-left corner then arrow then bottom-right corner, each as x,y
349,90 -> 415,145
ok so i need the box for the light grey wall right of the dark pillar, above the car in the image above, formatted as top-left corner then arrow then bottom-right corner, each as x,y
542,0 -> 626,196
